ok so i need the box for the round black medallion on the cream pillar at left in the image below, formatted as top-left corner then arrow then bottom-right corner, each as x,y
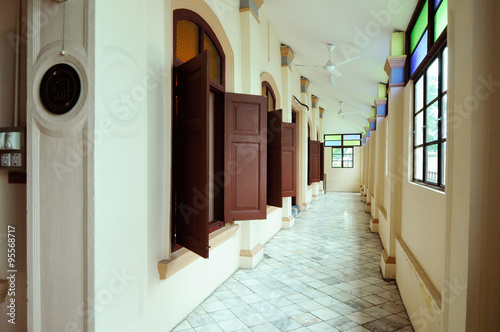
40,63 -> 81,115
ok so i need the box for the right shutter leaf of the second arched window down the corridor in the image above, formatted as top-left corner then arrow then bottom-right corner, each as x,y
281,122 -> 297,197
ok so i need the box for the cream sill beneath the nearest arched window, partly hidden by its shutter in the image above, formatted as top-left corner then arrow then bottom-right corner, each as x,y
158,224 -> 240,280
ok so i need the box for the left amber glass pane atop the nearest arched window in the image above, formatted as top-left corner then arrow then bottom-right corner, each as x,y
175,20 -> 200,62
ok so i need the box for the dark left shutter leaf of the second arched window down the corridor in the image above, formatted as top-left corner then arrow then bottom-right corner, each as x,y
267,110 -> 283,207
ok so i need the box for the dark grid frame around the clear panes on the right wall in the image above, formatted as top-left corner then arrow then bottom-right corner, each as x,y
411,44 -> 448,191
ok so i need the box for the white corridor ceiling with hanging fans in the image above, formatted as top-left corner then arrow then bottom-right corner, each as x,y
261,0 -> 417,133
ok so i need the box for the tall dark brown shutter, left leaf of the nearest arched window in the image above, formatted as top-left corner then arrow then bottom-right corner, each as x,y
174,51 -> 209,258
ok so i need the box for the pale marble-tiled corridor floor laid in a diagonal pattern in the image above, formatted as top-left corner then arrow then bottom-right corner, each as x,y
174,193 -> 413,332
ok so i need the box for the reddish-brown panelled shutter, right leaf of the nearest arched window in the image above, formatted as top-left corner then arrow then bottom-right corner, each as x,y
224,93 -> 267,222
